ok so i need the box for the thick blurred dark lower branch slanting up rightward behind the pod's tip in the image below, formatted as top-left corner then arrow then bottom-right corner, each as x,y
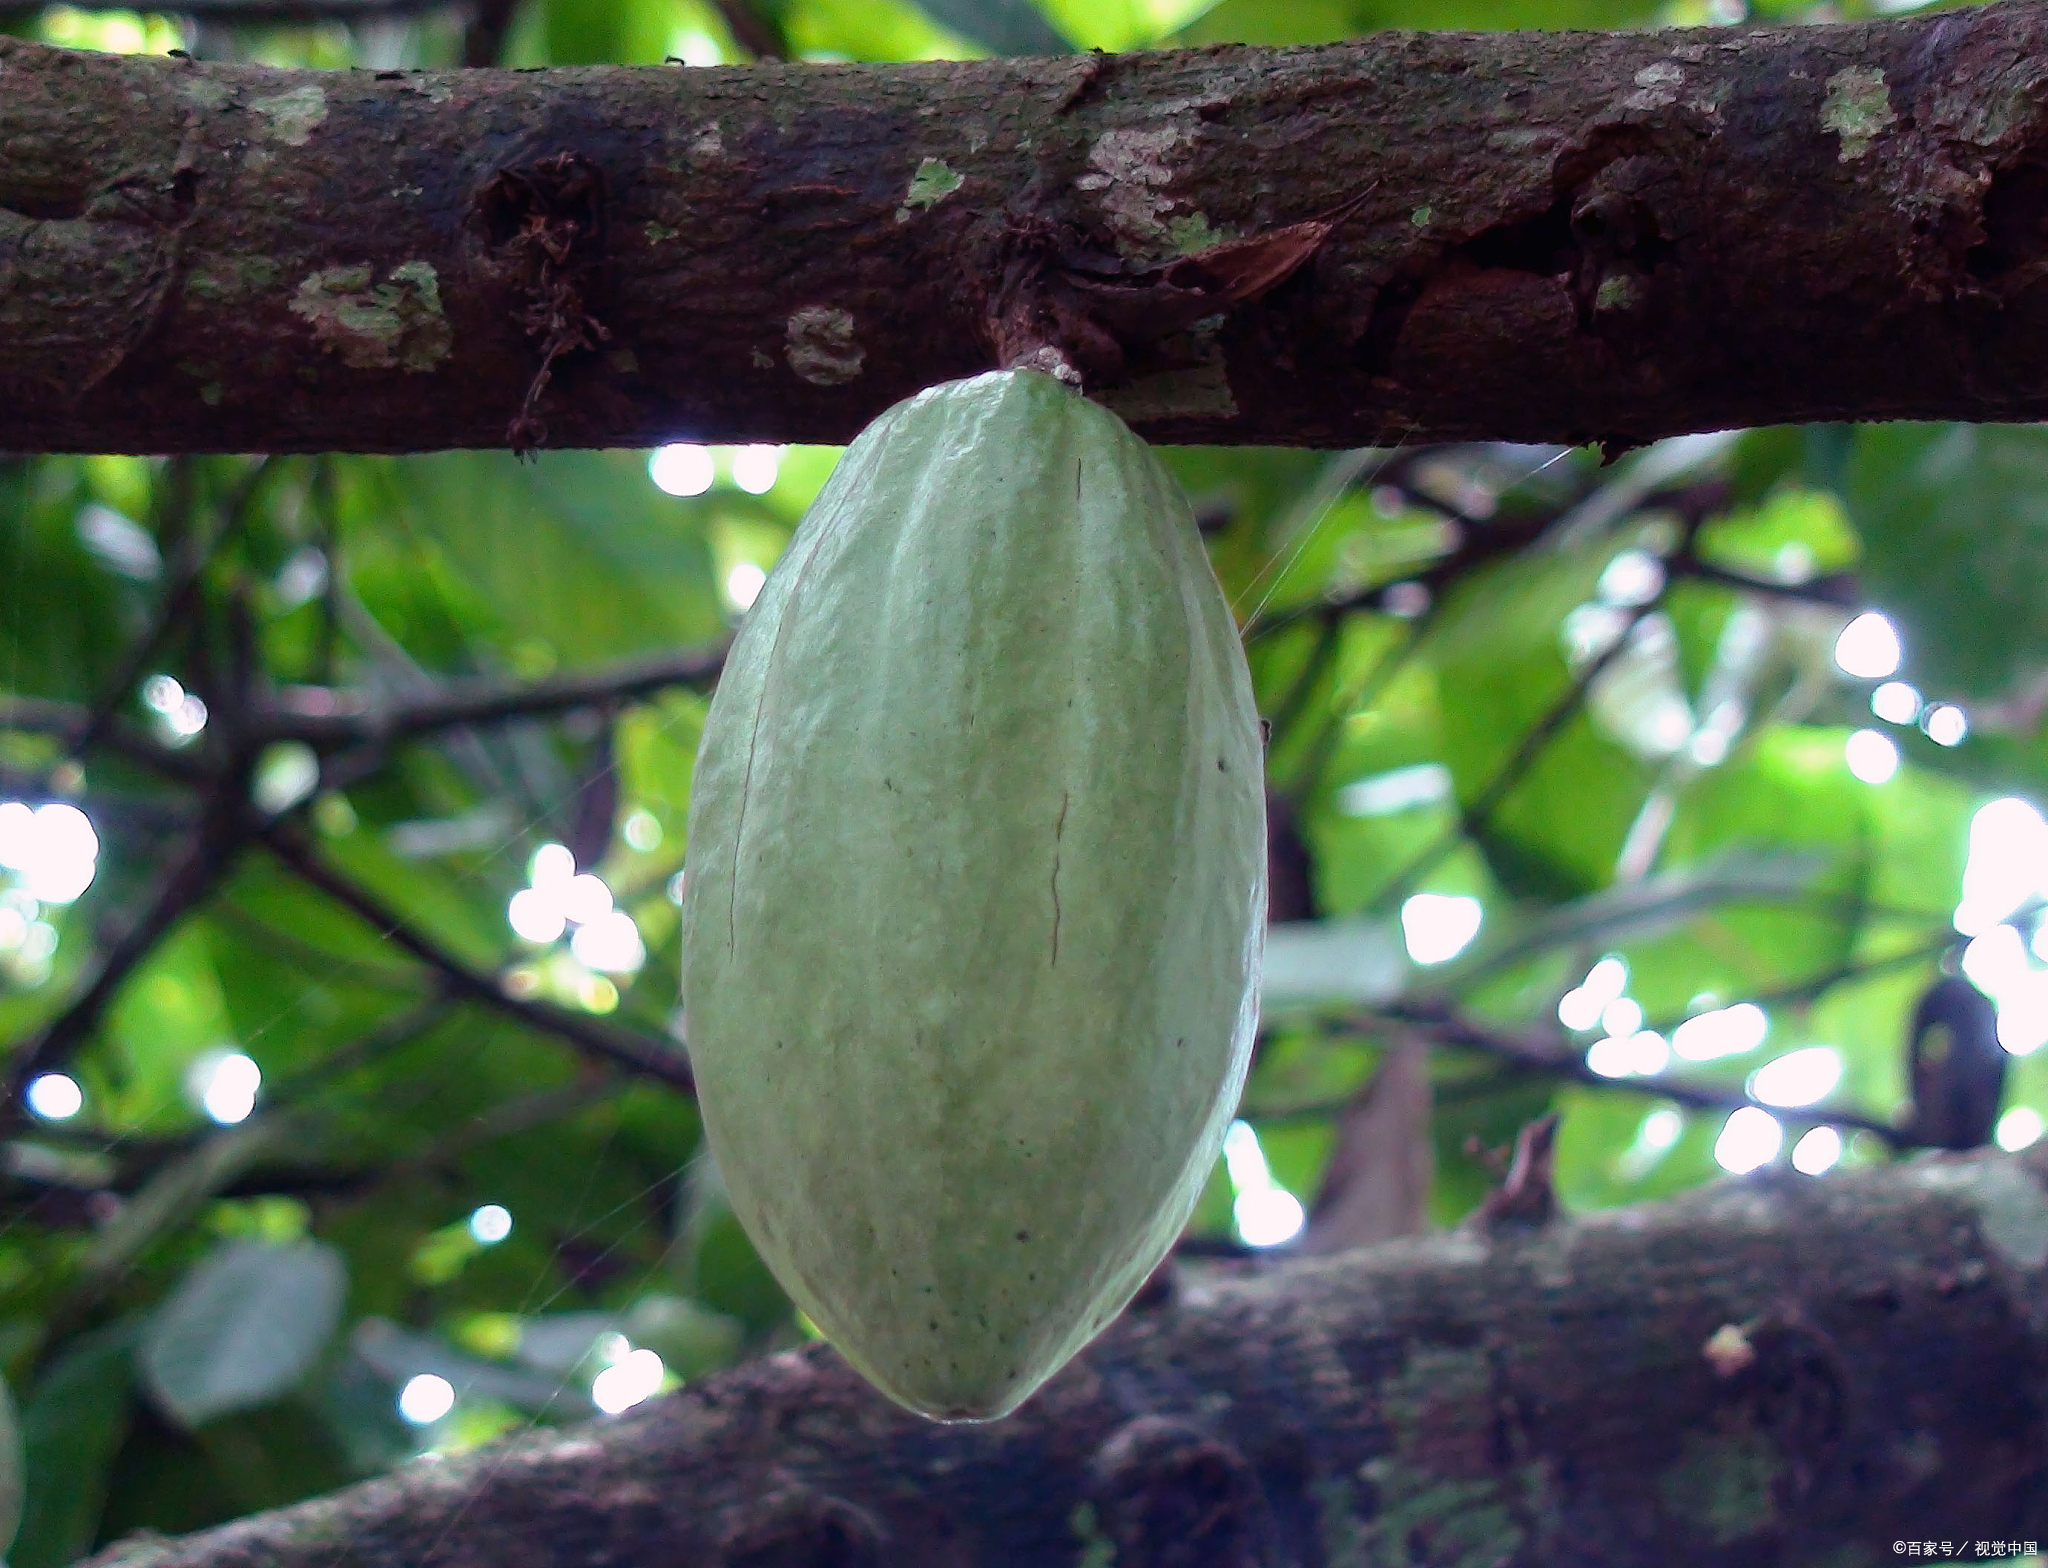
72,1155 -> 2048,1568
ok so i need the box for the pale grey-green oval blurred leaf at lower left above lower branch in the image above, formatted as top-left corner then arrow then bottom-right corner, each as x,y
137,1240 -> 348,1429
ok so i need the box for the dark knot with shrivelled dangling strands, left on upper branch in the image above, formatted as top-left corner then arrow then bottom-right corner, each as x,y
477,151 -> 612,456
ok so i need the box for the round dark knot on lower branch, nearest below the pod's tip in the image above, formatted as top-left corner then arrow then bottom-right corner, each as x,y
1092,1417 -> 1264,1568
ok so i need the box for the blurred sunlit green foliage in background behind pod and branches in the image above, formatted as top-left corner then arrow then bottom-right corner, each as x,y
0,0 -> 2048,1568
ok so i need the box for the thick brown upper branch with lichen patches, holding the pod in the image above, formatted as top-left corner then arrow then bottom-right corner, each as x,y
0,0 -> 2048,450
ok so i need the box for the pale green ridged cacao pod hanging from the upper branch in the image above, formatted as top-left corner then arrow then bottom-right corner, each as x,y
684,371 -> 1266,1421
